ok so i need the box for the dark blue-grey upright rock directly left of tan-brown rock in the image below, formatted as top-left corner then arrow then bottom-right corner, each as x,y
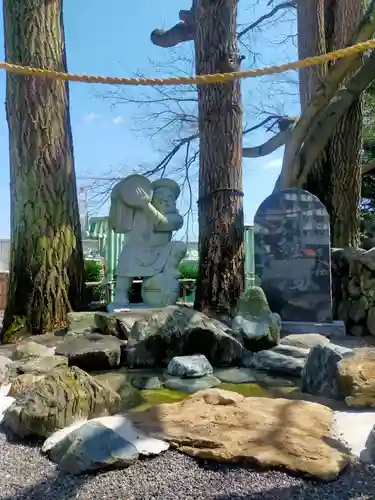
301,344 -> 354,399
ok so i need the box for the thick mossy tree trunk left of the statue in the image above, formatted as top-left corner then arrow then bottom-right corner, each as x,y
3,0 -> 83,341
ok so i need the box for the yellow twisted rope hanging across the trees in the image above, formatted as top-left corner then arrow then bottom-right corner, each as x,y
0,40 -> 375,86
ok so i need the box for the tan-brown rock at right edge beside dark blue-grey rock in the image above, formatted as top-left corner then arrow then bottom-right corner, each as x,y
337,348 -> 375,409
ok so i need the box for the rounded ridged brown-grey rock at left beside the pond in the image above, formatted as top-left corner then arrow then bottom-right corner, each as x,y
4,367 -> 120,437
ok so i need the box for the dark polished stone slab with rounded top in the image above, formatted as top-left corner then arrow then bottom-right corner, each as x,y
254,189 -> 332,322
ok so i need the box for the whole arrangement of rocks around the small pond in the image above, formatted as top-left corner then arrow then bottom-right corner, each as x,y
0,287 -> 375,480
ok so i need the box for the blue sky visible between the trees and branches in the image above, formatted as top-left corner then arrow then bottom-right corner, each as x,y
0,0 -> 298,239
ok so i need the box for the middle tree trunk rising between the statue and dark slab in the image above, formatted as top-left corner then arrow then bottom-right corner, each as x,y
193,0 -> 244,314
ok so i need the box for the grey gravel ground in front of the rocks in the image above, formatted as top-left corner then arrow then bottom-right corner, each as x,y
0,426 -> 375,500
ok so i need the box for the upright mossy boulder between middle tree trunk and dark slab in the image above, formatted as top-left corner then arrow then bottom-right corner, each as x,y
232,286 -> 281,352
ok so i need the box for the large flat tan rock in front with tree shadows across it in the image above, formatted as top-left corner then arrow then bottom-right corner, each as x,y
130,389 -> 351,481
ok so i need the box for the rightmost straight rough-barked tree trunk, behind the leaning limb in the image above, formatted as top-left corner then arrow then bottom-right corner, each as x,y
329,0 -> 363,248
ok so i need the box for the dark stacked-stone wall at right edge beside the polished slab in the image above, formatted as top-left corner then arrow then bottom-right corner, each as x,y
332,248 -> 375,337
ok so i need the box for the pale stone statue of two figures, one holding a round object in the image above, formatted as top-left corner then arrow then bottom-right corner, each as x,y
108,175 -> 187,311
